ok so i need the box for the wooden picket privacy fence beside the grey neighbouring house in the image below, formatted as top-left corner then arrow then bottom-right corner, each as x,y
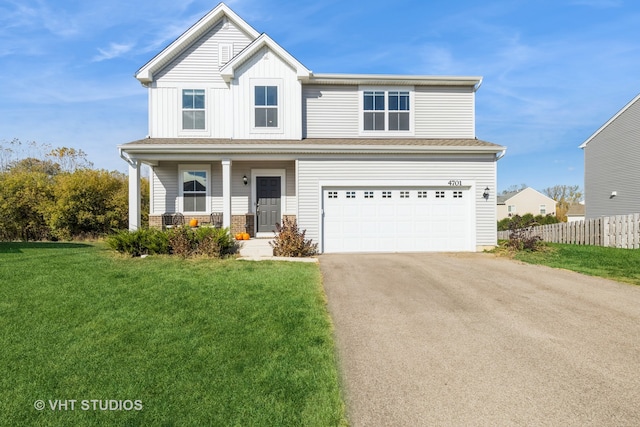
498,214 -> 640,249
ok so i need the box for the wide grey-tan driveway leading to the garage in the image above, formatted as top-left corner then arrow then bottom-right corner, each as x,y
320,254 -> 640,426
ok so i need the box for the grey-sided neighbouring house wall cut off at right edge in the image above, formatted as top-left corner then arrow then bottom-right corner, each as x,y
580,95 -> 640,218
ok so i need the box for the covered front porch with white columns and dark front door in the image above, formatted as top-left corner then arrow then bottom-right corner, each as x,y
120,146 -> 297,237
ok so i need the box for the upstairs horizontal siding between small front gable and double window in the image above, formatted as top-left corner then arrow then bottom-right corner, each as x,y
302,85 -> 359,138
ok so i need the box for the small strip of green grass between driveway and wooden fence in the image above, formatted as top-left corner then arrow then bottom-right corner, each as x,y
515,243 -> 640,285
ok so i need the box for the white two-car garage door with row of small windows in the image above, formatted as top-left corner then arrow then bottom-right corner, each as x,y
323,187 -> 473,253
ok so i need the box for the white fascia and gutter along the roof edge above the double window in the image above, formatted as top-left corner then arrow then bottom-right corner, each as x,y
308,74 -> 482,90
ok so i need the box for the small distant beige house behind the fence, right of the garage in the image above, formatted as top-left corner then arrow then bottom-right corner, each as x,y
496,187 -> 556,221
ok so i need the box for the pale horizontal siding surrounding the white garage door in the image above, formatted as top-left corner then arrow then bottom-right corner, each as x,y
298,154 -> 496,251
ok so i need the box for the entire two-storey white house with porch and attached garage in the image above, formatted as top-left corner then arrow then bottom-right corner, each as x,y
118,3 -> 505,252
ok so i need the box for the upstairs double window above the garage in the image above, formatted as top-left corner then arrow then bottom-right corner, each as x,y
362,90 -> 411,132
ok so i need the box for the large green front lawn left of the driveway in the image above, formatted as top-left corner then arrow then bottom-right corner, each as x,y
0,243 -> 346,426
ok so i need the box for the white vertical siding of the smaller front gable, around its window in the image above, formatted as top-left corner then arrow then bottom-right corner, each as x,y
231,47 -> 302,139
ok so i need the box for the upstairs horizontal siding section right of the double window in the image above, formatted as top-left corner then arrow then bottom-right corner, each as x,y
415,86 -> 476,138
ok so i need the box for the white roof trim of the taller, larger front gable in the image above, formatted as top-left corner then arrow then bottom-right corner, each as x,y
135,3 -> 260,84
